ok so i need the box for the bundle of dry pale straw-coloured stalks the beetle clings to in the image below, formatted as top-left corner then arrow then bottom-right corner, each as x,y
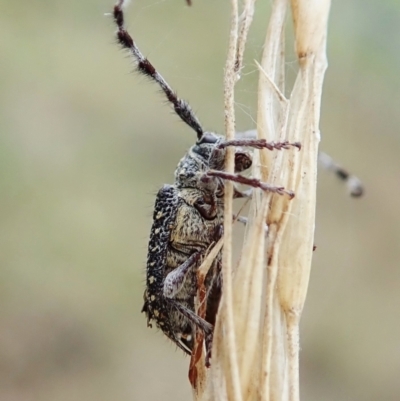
194,0 -> 330,401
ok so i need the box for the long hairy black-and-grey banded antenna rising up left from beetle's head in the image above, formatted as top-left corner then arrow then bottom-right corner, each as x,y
113,0 -> 204,139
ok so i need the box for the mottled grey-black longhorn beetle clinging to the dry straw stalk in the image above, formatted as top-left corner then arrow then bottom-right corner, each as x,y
113,0 -> 300,363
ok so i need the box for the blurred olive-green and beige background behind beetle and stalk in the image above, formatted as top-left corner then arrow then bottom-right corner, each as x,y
0,0 -> 400,401
